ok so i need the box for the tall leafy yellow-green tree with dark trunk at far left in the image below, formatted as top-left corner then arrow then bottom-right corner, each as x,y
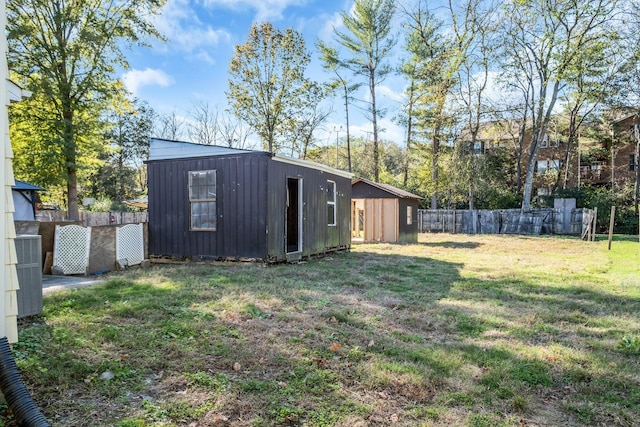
7,0 -> 164,219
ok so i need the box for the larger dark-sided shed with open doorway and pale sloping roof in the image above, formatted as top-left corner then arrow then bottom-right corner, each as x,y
147,139 -> 352,262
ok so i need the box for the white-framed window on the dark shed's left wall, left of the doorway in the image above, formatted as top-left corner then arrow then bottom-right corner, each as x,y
189,170 -> 217,231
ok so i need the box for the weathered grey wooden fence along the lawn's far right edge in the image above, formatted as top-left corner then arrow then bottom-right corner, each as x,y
418,208 -> 594,236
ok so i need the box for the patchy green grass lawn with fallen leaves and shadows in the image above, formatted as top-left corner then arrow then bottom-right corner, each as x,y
0,234 -> 640,427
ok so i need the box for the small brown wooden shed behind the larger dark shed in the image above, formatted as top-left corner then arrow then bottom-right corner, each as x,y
351,179 -> 422,243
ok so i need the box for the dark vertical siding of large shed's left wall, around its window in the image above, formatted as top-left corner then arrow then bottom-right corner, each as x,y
148,153 -> 269,259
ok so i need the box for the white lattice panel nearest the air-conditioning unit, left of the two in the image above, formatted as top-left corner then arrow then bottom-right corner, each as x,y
53,225 -> 91,274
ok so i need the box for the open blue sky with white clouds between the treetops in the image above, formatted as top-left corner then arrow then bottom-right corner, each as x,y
122,0 -> 410,143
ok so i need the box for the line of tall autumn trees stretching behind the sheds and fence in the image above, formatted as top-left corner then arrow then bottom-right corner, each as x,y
7,0 -> 640,231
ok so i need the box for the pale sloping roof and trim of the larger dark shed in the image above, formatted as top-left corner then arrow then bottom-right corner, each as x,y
149,138 -> 353,178
